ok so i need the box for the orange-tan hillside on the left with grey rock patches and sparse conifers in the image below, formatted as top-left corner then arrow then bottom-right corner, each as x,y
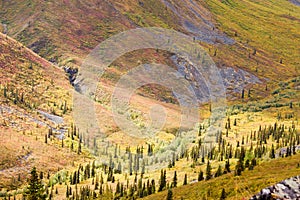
0,34 -> 91,193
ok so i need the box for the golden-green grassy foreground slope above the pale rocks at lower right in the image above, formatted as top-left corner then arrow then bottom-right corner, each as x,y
144,154 -> 300,200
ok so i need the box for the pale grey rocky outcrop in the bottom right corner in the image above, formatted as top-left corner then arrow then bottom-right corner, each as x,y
251,175 -> 300,200
